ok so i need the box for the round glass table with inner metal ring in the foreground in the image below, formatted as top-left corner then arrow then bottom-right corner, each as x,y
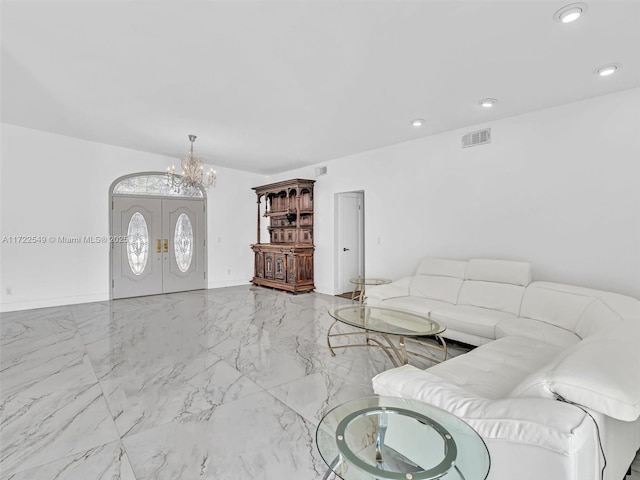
316,397 -> 490,480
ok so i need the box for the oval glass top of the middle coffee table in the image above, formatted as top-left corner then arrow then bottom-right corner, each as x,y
329,305 -> 445,337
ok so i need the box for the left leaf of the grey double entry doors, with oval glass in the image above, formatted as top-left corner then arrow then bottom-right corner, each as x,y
111,197 -> 163,298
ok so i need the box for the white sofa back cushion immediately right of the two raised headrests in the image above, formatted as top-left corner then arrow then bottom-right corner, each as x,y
520,282 -> 596,332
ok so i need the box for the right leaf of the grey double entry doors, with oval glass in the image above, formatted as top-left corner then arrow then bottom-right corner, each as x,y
162,199 -> 206,293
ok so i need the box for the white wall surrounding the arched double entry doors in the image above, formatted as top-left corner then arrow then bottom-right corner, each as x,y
0,124 -> 265,311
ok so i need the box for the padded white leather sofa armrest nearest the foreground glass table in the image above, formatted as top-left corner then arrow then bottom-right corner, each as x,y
373,365 -> 595,455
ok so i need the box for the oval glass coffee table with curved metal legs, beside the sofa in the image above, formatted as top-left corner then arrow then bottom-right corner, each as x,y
327,304 -> 447,367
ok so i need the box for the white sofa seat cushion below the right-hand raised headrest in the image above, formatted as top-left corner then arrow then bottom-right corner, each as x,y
431,305 -> 516,339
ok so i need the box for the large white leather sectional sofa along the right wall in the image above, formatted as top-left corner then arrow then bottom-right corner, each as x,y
367,259 -> 640,480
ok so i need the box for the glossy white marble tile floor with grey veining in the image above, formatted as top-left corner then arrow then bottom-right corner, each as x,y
0,286 -> 640,480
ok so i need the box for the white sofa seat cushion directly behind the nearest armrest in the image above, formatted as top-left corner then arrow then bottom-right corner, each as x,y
428,337 -> 560,399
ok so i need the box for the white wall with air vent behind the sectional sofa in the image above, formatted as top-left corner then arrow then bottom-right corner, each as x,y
269,88 -> 640,297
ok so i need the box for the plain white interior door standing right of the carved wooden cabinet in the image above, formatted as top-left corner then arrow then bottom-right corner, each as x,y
336,192 -> 364,293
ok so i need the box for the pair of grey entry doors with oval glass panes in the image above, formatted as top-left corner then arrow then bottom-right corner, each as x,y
111,196 -> 206,299
